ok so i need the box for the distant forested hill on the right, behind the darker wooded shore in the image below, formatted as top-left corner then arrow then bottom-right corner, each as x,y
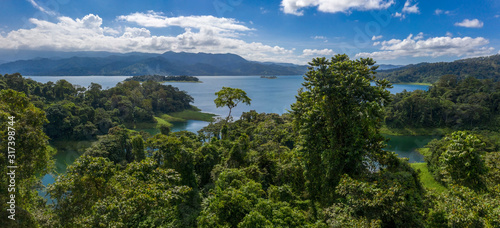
377,55 -> 500,83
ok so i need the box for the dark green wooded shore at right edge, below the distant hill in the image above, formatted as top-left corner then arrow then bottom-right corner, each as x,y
385,75 -> 500,131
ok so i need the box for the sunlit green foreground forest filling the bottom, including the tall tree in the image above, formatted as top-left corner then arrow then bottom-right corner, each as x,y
0,55 -> 500,227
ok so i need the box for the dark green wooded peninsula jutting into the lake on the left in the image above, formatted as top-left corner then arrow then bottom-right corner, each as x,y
0,74 -> 193,140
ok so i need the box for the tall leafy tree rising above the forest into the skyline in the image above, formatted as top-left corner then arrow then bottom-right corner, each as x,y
292,55 -> 391,206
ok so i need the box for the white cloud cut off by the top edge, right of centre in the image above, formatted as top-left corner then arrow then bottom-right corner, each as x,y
281,0 -> 394,16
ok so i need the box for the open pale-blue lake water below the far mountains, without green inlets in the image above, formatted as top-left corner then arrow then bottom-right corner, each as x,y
28,75 -> 428,121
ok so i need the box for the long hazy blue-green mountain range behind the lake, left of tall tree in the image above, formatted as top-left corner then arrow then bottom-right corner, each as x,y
0,52 -> 307,76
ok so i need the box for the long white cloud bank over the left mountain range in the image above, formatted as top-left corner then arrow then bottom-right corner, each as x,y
0,14 -> 304,64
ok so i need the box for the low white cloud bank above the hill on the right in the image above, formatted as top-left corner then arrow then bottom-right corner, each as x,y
356,33 -> 494,60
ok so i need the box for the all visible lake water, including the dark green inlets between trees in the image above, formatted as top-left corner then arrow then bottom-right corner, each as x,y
28,75 -> 433,196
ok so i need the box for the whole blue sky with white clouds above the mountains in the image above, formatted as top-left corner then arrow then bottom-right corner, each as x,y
0,0 -> 500,65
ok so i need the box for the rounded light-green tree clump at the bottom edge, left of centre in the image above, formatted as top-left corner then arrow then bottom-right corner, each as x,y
49,155 -> 190,227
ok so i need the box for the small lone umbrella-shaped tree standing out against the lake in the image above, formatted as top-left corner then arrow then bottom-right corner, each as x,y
214,87 -> 252,121
